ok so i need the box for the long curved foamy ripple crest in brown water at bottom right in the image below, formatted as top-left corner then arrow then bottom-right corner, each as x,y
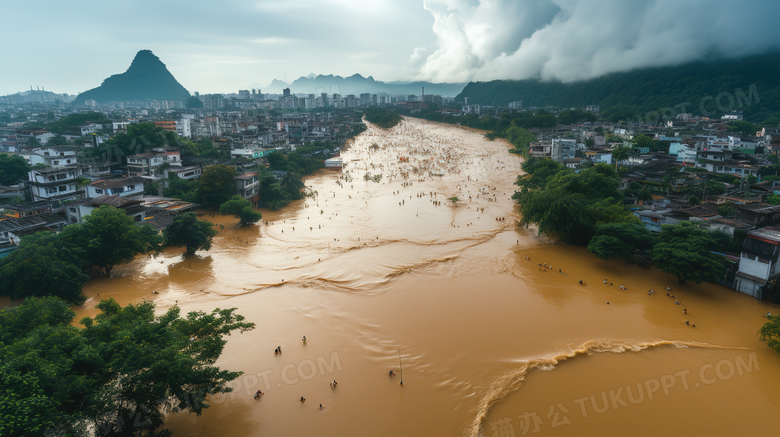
464,339 -> 746,437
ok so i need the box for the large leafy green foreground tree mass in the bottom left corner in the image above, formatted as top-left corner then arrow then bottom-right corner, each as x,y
0,298 -> 255,436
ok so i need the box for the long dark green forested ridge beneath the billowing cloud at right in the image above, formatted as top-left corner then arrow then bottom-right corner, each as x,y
456,53 -> 780,122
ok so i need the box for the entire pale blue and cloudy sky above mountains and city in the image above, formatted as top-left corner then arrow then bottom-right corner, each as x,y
0,0 -> 780,95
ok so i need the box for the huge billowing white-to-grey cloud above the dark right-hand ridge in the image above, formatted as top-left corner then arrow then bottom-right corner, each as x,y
412,0 -> 780,82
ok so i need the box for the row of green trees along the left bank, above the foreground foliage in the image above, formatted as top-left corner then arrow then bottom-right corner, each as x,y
0,205 -> 216,305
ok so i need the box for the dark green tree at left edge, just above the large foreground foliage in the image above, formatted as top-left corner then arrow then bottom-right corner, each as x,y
0,232 -> 89,305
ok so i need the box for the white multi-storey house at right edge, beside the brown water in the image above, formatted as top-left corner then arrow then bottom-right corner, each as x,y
734,227 -> 780,299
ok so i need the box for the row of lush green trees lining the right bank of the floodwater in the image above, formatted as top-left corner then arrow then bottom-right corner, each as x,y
514,158 -> 739,283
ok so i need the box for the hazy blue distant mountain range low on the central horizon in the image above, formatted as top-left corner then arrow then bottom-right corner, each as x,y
252,74 -> 466,96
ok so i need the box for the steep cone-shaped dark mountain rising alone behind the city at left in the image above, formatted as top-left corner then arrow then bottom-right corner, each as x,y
74,50 -> 190,104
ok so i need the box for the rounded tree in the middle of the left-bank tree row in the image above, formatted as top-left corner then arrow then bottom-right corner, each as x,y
77,205 -> 159,275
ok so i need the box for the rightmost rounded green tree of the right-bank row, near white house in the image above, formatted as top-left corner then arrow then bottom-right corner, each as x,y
650,222 -> 726,284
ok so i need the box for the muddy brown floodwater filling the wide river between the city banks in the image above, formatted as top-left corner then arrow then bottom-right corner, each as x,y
29,119 -> 780,437
